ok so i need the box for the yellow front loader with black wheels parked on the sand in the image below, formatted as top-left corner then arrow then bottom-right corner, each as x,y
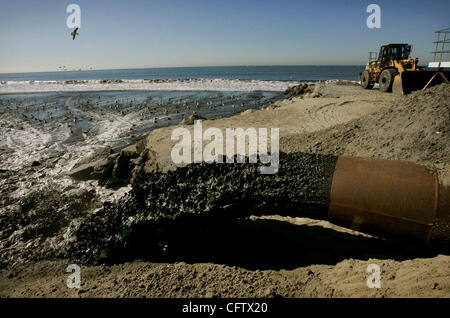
360,44 -> 450,94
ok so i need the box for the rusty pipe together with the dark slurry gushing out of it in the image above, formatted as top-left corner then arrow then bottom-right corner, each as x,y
68,153 -> 450,263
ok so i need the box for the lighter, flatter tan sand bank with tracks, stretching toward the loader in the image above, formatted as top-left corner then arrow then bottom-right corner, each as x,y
134,80 -> 403,172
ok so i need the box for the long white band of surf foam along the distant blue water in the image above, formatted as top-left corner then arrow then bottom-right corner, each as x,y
0,78 -> 299,94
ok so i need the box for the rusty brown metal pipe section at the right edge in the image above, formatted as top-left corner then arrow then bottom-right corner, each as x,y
328,156 -> 450,248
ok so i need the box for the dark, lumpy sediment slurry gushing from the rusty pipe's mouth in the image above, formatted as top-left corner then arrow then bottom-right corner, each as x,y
68,153 -> 337,263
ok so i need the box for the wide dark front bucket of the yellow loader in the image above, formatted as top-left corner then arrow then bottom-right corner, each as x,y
392,71 -> 450,94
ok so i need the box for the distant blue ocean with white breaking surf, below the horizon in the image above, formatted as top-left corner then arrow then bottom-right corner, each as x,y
0,66 -> 363,94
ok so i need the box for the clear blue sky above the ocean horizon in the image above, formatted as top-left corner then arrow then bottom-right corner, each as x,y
0,0 -> 450,73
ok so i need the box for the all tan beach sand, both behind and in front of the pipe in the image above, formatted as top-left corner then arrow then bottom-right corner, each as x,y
0,82 -> 450,297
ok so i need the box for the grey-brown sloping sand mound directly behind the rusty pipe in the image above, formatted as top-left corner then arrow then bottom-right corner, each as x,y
280,84 -> 450,163
